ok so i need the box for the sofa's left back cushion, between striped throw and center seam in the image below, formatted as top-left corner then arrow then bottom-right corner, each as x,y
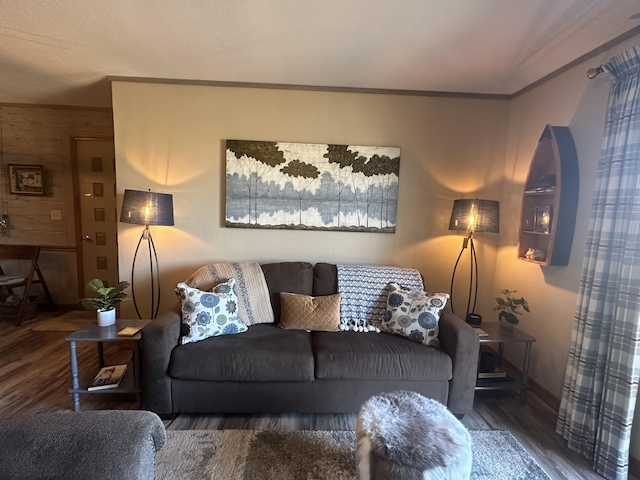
261,262 -> 313,323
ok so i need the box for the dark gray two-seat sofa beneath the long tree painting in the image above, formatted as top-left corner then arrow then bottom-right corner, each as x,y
142,262 -> 479,416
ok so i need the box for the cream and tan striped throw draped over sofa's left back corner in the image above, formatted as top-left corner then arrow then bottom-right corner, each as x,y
184,262 -> 274,326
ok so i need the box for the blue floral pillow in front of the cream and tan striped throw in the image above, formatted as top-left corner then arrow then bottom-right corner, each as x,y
176,278 -> 247,345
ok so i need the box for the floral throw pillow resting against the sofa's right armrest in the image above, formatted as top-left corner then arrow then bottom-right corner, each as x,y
380,283 -> 449,347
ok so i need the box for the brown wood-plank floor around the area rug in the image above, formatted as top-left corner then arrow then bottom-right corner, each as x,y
0,312 -> 638,480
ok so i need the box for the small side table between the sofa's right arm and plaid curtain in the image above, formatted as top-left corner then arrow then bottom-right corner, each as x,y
476,322 -> 536,404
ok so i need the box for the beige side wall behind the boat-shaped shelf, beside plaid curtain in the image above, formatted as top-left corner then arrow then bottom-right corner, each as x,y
495,36 -> 640,458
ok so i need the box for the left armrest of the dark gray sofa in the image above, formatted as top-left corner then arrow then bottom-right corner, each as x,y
142,304 -> 181,415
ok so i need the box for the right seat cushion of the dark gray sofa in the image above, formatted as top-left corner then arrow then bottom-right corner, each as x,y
311,332 -> 452,380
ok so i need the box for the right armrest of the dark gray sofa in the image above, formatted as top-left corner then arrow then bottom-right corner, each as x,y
438,309 -> 480,415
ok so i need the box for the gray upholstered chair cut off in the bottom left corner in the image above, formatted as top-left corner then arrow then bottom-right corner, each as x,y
0,410 -> 166,480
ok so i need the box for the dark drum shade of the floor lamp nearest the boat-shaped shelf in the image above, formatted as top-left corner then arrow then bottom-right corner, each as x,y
449,198 -> 500,233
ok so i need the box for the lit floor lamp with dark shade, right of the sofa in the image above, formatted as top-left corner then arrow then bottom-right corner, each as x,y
449,198 -> 500,325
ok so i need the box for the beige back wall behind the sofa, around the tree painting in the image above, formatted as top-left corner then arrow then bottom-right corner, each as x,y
113,82 -> 508,318
